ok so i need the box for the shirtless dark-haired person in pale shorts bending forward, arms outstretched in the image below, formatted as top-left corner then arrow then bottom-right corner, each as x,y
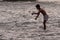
32,4 -> 48,30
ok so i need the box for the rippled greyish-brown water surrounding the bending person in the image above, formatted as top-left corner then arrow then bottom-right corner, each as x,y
0,2 -> 60,40
